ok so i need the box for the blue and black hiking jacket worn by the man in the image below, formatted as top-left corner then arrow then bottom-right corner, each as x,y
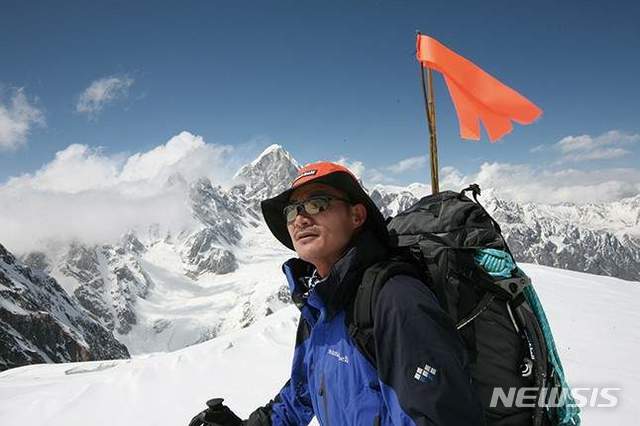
246,232 -> 484,426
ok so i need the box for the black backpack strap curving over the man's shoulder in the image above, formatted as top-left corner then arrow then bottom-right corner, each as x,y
348,259 -> 424,366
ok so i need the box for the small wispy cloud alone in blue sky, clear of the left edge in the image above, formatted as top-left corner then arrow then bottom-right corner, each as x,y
76,76 -> 134,117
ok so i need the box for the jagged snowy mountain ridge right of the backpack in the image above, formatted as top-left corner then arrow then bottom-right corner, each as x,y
484,196 -> 640,281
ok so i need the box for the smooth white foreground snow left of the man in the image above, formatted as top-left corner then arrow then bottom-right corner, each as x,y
0,307 -> 297,426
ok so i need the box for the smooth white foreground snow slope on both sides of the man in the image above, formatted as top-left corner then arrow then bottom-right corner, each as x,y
0,264 -> 640,426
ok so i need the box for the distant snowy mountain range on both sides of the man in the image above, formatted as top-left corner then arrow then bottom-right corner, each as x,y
5,145 -> 640,362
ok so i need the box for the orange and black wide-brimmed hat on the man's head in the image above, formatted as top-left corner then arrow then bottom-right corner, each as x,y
260,161 -> 389,250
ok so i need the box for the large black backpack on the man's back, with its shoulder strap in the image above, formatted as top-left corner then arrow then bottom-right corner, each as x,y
350,185 -> 556,426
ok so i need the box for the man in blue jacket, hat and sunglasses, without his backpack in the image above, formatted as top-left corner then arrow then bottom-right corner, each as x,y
191,162 -> 483,426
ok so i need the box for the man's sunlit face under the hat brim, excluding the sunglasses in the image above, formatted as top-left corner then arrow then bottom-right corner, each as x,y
287,183 -> 367,276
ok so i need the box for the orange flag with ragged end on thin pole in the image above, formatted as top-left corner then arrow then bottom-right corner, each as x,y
416,34 -> 542,142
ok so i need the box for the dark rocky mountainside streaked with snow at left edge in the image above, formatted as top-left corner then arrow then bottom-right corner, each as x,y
0,241 -> 129,371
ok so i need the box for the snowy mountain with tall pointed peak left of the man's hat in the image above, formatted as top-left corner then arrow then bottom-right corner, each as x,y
11,145 -> 299,353
